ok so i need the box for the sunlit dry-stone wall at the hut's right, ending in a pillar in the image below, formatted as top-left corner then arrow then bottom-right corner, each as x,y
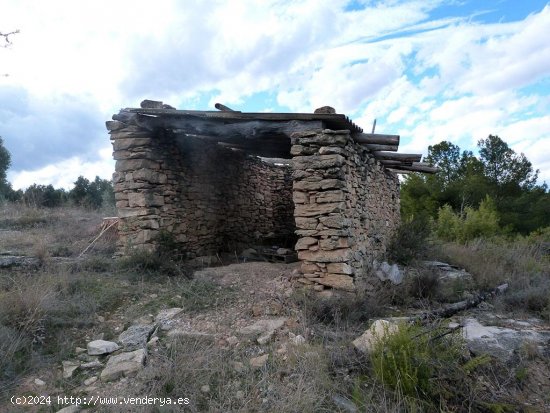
291,130 -> 399,291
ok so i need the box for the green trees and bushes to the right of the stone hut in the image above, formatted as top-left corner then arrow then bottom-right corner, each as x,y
401,135 -> 550,241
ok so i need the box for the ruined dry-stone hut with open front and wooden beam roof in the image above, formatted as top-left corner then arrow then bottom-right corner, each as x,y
106,100 -> 435,291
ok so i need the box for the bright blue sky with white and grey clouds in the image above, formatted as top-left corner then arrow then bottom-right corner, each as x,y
0,0 -> 550,188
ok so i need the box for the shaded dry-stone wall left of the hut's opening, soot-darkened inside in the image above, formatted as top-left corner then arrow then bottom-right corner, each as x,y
107,121 -> 295,257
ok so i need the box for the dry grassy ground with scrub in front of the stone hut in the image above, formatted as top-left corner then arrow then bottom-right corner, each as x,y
0,206 -> 550,412
